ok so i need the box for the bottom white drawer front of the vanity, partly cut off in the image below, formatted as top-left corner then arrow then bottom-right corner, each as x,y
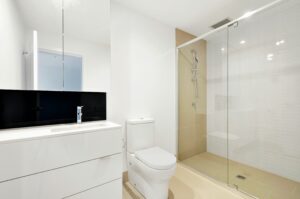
65,179 -> 122,199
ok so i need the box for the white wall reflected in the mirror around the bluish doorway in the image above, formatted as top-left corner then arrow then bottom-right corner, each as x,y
38,31 -> 110,92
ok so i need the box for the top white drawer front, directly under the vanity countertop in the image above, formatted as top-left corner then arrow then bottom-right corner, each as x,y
0,128 -> 122,182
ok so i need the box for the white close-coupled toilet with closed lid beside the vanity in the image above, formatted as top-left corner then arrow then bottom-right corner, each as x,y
127,118 -> 176,199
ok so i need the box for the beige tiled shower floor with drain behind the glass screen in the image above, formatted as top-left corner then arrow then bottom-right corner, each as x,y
181,152 -> 300,199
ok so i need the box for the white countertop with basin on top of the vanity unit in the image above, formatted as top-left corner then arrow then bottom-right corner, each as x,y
0,121 -> 121,144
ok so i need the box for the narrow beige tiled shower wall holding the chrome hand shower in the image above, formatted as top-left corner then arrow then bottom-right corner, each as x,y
176,30 -> 206,160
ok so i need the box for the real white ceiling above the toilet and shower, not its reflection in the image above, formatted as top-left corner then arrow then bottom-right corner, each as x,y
112,0 -> 274,36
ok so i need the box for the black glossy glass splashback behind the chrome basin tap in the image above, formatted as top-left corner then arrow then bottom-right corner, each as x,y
0,90 -> 106,129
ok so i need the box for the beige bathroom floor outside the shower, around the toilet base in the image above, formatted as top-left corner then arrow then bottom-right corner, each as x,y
123,163 -> 250,199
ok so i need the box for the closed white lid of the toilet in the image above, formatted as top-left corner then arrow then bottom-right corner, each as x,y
135,147 -> 176,170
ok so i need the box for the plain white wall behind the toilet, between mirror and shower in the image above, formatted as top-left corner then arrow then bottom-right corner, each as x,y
108,3 -> 176,170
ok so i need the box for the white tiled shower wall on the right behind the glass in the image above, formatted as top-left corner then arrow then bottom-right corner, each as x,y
207,1 -> 300,182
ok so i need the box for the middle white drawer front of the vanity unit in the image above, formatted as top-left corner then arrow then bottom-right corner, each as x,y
0,154 -> 122,199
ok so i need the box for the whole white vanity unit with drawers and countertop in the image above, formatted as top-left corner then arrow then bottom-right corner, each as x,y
0,121 -> 122,199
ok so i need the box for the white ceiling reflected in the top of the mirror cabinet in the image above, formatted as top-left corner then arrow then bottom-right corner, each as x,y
15,0 -> 110,44
